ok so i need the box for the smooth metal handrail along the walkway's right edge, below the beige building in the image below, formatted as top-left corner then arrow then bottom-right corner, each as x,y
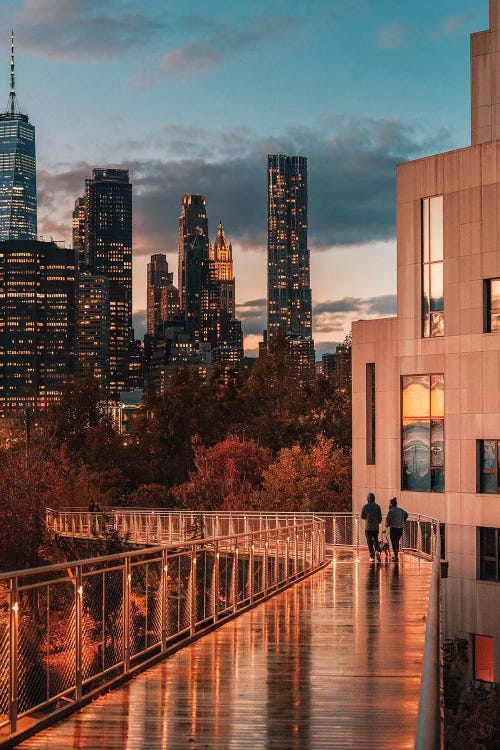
415,523 -> 442,750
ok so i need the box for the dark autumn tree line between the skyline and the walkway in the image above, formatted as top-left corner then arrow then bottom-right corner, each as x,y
0,337 -> 351,570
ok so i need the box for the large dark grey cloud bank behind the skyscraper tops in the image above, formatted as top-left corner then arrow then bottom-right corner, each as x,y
38,117 -> 449,262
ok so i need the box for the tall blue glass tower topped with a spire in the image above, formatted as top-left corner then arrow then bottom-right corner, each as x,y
0,34 -> 37,240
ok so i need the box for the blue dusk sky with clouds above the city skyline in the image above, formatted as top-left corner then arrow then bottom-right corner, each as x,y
0,0 -> 488,355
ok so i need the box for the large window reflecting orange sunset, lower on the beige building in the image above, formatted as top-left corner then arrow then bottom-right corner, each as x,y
401,374 -> 445,492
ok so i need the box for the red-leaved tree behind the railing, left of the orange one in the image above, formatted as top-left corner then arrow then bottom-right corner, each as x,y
173,435 -> 270,510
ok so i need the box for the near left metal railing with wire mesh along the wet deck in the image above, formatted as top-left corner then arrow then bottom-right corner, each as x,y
0,514 -> 325,745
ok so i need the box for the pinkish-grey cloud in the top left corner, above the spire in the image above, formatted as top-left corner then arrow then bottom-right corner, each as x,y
4,0 -> 167,60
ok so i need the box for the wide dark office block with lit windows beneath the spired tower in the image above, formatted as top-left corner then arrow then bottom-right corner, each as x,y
0,240 -> 75,413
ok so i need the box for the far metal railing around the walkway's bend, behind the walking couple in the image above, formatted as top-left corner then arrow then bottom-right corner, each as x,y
47,508 -> 437,560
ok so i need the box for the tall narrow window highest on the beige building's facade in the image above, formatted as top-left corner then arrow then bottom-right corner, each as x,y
422,200 -> 444,338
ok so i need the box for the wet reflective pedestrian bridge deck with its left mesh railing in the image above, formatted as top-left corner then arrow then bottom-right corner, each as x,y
0,516 -> 436,750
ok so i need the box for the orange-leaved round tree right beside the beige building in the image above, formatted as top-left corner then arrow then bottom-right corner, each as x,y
253,436 -> 351,511
